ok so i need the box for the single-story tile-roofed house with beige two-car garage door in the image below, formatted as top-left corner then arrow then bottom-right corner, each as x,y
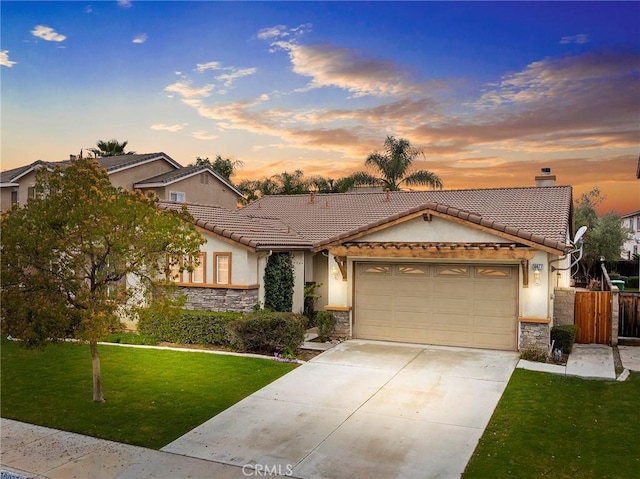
159,172 -> 572,350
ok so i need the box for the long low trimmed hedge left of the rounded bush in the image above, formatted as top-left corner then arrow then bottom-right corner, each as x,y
138,310 -> 242,346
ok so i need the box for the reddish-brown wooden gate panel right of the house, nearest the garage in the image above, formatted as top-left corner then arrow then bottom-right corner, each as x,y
575,291 -> 611,344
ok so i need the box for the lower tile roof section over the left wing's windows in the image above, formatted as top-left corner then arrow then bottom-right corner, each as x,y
158,201 -> 312,251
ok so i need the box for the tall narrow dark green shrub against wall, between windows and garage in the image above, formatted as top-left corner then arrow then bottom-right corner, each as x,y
264,253 -> 294,311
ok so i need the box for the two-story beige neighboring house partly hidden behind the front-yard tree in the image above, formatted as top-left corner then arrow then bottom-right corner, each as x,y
0,153 -> 242,210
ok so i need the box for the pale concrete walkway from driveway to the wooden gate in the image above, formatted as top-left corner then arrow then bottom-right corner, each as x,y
517,344 -> 624,380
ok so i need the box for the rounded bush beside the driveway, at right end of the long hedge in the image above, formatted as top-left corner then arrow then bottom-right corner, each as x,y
228,310 -> 307,354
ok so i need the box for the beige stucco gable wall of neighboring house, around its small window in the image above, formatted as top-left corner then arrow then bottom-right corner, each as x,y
159,174 -> 238,210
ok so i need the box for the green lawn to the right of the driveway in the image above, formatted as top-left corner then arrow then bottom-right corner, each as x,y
464,369 -> 640,479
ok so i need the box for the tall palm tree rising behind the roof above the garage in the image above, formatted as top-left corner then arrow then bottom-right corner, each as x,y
350,136 -> 442,191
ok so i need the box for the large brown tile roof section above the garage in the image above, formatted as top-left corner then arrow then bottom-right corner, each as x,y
240,186 -> 572,255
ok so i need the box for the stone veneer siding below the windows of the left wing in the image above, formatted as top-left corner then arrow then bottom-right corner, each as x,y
180,286 -> 258,313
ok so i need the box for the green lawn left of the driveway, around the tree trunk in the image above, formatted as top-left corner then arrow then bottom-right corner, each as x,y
0,339 -> 296,449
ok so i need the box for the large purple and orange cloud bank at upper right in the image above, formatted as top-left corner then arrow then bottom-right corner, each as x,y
415,52 -> 640,153
